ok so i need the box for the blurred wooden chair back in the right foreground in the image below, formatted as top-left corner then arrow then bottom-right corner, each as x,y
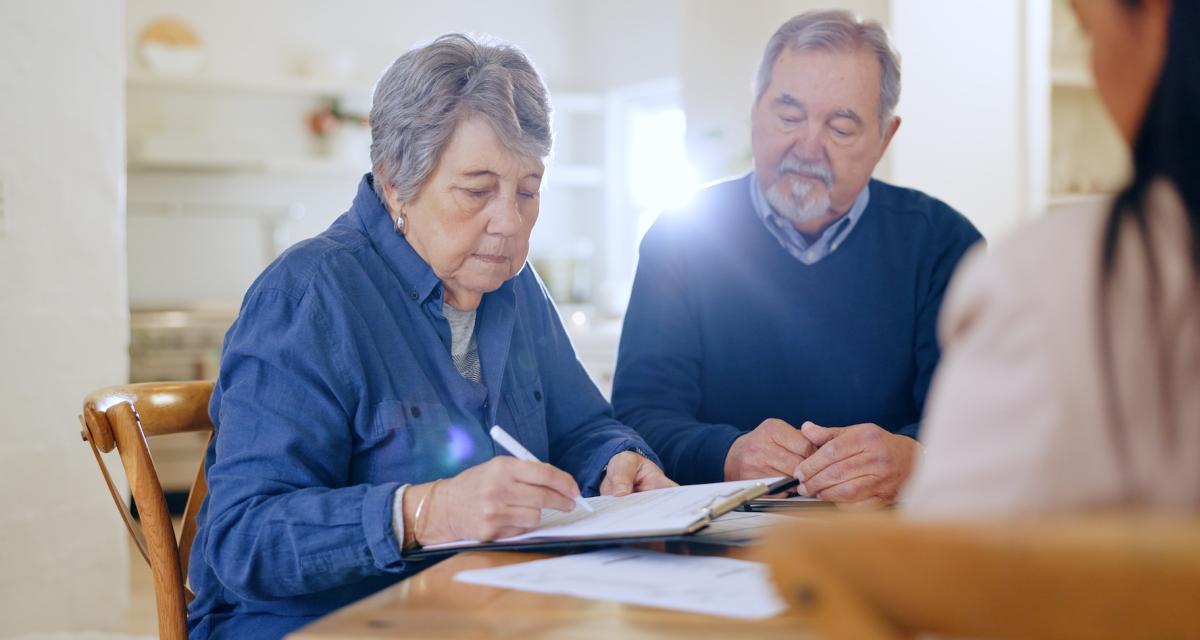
758,514 -> 1200,640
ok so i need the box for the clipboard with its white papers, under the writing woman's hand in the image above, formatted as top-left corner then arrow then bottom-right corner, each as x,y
404,477 -> 796,558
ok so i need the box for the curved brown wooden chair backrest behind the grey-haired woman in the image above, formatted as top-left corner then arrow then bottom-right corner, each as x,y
79,381 -> 212,640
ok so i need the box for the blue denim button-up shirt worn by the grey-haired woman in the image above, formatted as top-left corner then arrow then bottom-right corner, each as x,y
188,175 -> 658,638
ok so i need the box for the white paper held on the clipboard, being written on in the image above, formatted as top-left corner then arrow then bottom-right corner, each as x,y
425,478 -> 780,551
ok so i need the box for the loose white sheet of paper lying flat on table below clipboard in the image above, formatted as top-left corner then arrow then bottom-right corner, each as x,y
455,549 -> 787,620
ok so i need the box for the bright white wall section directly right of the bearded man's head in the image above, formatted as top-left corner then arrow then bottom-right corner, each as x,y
890,0 -> 1045,239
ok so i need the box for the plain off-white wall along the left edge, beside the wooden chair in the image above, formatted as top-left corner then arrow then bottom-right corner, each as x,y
0,0 -> 128,635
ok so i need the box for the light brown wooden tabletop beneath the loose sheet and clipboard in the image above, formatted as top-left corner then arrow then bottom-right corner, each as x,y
288,543 -> 812,640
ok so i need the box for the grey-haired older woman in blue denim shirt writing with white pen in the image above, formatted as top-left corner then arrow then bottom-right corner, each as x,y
190,35 -> 673,638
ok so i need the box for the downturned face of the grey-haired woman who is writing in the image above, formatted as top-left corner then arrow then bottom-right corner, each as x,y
385,114 -> 544,310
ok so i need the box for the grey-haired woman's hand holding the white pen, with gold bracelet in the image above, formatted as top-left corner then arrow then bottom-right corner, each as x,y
404,455 -> 580,545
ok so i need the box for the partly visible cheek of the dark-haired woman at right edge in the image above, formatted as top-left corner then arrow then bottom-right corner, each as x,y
1072,0 -> 1166,144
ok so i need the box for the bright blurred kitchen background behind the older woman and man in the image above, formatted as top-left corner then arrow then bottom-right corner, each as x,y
125,0 -> 1124,393
